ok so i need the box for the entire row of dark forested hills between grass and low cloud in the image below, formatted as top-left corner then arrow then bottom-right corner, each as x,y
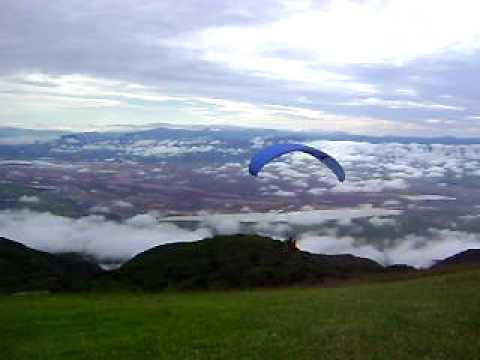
0,235 -> 480,293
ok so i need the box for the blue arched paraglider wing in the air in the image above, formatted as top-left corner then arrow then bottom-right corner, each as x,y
248,143 -> 345,182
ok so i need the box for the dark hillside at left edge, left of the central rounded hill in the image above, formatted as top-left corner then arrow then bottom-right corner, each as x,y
0,237 -> 102,292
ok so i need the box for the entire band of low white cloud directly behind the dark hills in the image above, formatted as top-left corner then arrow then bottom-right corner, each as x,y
0,210 -> 480,267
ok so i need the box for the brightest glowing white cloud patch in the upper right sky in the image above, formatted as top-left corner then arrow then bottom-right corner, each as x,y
171,0 -> 480,69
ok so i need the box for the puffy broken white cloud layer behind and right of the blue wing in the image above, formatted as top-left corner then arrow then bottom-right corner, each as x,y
240,140 -> 480,197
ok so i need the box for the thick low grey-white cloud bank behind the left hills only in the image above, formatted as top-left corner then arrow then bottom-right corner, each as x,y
0,210 -> 211,262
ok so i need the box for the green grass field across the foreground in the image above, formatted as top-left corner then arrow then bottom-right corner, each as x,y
0,270 -> 480,360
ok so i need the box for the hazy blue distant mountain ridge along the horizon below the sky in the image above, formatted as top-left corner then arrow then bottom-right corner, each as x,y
0,124 -> 480,160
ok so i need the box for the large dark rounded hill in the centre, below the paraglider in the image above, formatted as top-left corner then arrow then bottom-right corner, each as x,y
109,235 -> 384,291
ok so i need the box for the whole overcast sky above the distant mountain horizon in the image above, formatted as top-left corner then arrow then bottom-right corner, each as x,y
0,0 -> 480,136
